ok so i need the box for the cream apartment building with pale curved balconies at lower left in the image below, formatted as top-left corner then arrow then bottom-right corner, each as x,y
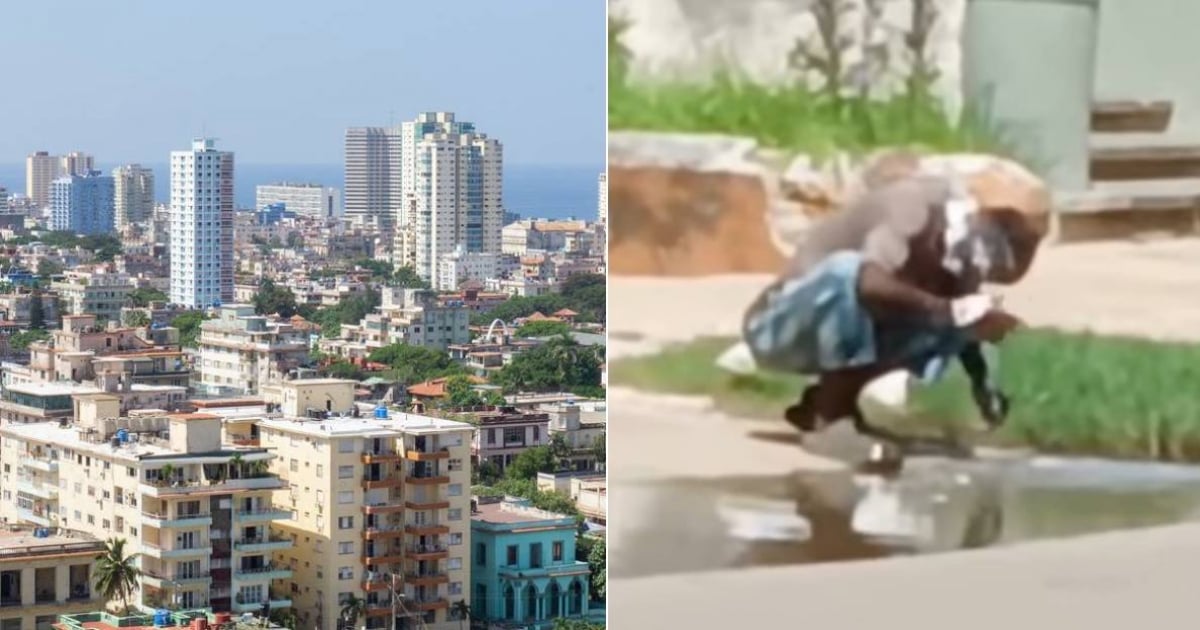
0,394 -> 294,612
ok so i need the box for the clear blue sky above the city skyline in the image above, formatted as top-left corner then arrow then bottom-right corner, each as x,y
0,0 -> 606,164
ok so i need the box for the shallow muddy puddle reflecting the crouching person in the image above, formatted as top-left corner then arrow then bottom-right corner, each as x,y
608,457 -> 1200,577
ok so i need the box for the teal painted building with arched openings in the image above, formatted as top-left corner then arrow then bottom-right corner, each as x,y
470,499 -> 604,630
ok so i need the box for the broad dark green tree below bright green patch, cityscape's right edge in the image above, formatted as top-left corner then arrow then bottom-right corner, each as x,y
494,336 -> 600,395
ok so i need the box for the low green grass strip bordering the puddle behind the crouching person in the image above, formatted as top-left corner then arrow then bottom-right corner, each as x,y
611,329 -> 1200,461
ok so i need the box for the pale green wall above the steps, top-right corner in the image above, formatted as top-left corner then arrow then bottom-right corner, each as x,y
1096,0 -> 1200,142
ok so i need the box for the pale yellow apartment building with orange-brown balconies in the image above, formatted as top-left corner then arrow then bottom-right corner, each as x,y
258,379 -> 474,630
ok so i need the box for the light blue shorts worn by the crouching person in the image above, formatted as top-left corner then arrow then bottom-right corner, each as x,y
743,251 -> 971,380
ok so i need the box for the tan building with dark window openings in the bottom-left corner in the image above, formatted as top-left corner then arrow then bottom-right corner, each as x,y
0,523 -> 104,630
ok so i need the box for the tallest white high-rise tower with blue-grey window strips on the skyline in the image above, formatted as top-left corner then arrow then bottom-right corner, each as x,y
398,112 -> 504,282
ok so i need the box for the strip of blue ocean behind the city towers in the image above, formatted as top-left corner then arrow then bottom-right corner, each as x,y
0,162 -> 604,220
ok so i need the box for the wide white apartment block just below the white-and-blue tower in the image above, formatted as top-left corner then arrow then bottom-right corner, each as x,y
198,304 -> 308,396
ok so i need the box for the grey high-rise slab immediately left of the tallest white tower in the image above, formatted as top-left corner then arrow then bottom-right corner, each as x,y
346,127 -> 402,229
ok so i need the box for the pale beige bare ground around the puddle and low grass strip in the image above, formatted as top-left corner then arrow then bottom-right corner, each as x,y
608,240 -> 1200,630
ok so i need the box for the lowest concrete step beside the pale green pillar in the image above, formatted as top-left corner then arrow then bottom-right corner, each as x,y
1055,178 -> 1200,242
